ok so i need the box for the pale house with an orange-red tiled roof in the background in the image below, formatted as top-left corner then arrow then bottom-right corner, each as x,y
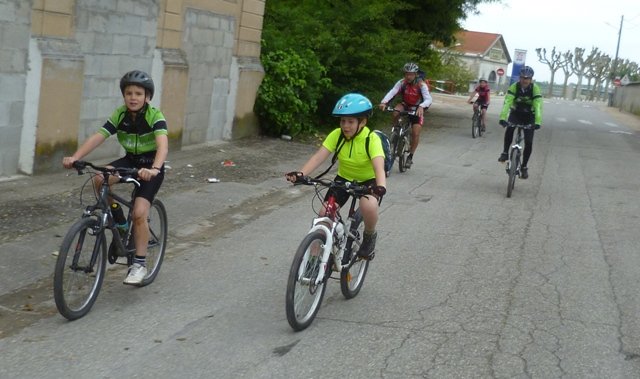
449,30 -> 511,92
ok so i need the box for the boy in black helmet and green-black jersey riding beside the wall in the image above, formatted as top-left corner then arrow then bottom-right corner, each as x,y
62,70 -> 169,285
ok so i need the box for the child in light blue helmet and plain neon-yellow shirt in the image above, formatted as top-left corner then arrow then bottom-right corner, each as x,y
286,93 -> 387,259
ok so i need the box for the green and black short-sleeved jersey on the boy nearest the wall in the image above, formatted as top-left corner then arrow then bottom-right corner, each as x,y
99,104 -> 167,155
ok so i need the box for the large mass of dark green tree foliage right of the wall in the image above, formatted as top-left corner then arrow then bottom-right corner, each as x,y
256,0 -> 497,133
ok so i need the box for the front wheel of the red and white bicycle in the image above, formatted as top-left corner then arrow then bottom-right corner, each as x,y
285,230 -> 327,331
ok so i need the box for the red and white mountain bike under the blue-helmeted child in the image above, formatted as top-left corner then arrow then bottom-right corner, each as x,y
285,177 -> 370,331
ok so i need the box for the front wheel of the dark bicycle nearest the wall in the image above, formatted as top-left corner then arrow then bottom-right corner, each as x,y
53,218 -> 107,321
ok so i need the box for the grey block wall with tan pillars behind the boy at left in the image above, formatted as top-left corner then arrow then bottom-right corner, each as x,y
0,0 -> 265,178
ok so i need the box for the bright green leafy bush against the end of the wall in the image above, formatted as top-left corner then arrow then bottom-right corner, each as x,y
255,49 -> 331,136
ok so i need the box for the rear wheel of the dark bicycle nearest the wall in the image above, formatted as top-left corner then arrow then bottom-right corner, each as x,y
138,199 -> 168,287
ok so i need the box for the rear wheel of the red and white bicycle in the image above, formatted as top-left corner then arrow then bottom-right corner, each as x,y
340,209 -> 369,299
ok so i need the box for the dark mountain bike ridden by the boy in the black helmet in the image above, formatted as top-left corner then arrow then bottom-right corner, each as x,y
53,161 -> 167,320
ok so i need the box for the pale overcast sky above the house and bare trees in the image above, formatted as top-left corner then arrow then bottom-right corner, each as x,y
461,0 -> 640,83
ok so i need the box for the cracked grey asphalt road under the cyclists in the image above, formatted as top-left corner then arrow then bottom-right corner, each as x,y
0,96 -> 640,378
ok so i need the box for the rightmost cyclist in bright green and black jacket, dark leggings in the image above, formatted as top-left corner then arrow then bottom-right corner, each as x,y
498,66 -> 542,179
